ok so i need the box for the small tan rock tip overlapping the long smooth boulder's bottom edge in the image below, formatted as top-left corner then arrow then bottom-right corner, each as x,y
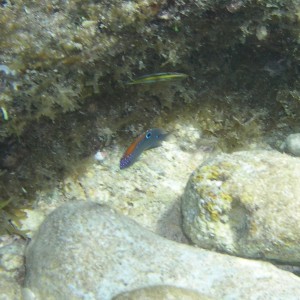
113,285 -> 212,300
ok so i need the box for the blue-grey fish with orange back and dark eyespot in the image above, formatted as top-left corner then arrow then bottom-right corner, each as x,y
120,128 -> 168,169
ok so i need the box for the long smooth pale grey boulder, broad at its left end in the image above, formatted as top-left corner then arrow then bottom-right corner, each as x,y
24,201 -> 300,300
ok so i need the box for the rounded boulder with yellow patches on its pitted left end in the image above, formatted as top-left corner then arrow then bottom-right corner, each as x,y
182,151 -> 300,265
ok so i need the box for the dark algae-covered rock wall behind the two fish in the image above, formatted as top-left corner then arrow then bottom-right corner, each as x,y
0,0 -> 300,234
